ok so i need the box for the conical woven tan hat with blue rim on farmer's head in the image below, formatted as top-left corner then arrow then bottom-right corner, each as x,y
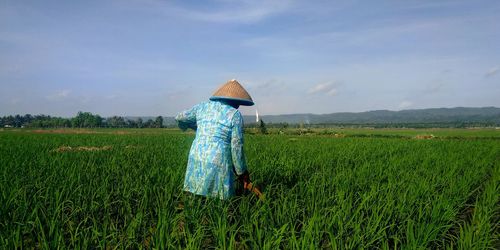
210,79 -> 254,106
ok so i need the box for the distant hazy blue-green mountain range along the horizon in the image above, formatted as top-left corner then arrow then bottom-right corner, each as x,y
132,107 -> 500,126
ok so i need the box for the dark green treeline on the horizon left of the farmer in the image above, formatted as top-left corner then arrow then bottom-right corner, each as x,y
0,112 -> 164,128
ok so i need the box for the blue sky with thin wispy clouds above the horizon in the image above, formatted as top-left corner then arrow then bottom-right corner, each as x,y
0,0 -> 500,116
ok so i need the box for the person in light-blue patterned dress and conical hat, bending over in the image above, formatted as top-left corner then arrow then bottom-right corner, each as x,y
175,79 -> 254,200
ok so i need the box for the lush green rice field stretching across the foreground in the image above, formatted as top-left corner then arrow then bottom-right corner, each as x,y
0,129 -> 500,249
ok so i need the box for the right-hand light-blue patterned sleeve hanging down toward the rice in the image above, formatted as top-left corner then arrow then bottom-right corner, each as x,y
231,111 -> 247,175
